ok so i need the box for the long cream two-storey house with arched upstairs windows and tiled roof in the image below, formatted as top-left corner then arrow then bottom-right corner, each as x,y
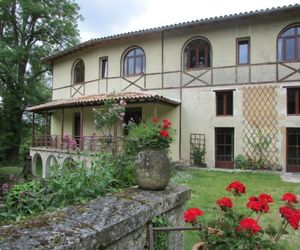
28,4 -> 300,175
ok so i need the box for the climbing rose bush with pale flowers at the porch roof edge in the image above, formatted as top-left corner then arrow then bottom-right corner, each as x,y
94,100 -> 126,136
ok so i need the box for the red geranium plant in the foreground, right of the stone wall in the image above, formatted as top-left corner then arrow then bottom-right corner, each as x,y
184,181 -> 300,250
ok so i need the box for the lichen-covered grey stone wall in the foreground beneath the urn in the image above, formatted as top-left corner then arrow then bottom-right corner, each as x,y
0,185 -> 190,250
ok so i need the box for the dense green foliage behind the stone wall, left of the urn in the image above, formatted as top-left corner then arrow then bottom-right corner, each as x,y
0,153 -> 135,224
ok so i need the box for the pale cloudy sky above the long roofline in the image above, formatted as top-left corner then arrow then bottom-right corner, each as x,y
75,0 -> 299,42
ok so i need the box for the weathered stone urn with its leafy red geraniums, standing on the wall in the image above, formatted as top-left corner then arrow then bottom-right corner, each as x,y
126,117 -> 174,190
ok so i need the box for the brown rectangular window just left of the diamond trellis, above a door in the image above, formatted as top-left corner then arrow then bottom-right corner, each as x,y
216,91 -> 233,116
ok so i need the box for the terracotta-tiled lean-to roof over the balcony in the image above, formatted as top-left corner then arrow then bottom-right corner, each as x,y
26,92 -> 180,112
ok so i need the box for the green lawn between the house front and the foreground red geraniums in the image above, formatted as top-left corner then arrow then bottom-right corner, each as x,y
172,169 -> 300,250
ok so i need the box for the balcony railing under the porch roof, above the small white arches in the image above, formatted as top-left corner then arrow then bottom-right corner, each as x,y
32,135 -> 124,153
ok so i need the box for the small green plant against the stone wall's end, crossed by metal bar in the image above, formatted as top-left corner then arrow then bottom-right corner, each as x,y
151,216 -> 170,250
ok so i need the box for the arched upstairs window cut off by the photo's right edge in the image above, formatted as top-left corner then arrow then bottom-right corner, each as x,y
278,25 -> 300,62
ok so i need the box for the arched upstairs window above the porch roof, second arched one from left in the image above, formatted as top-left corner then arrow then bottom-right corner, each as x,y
123,48 -> 145,76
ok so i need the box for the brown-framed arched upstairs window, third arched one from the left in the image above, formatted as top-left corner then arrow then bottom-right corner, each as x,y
184,38 -> 211,69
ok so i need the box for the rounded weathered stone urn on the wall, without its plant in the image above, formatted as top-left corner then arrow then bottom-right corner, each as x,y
135,149 -> 171,190
